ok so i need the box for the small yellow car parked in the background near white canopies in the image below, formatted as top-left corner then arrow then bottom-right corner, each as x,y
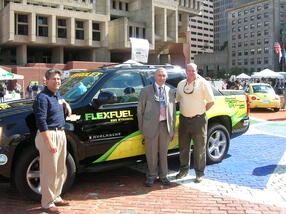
244,83 -> 281,111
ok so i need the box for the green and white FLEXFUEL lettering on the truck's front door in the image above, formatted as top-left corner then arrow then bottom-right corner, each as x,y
84,110 -> 134,122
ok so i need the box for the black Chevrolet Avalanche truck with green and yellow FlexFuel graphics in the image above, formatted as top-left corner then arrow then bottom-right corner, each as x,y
0,65 -> 249,200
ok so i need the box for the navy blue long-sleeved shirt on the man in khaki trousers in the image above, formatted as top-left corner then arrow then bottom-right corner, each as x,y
33,87 -> 65,132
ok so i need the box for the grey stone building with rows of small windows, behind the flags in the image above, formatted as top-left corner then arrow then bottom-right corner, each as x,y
228,0 -> 286,72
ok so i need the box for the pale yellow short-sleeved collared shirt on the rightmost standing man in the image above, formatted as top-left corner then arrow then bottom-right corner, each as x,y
176,76 -> 214,117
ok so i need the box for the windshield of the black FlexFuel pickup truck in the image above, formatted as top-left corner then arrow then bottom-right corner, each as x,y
60,72 -> 103,103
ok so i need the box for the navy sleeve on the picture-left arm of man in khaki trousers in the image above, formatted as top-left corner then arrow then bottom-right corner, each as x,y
33,96 -> 48,132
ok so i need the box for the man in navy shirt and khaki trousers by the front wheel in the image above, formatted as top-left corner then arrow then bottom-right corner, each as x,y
33,69 -> 71,213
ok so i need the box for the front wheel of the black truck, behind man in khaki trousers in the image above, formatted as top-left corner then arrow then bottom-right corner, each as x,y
14,146 -> 76,201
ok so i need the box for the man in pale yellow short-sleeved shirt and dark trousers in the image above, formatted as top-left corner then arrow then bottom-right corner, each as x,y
176,63 -> 214,182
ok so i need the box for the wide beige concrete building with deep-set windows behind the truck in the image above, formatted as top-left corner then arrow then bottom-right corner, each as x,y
0,0 -> 202,65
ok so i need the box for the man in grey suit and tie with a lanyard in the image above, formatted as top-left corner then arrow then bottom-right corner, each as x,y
137,68 -> 176,187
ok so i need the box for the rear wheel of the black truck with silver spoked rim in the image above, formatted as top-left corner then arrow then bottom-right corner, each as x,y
206,123 -> 230,164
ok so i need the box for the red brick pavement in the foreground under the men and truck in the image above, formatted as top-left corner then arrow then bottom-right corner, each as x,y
0,111 -> 286,214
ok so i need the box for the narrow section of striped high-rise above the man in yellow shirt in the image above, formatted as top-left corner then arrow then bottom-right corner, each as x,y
190,0 -> 214,62
